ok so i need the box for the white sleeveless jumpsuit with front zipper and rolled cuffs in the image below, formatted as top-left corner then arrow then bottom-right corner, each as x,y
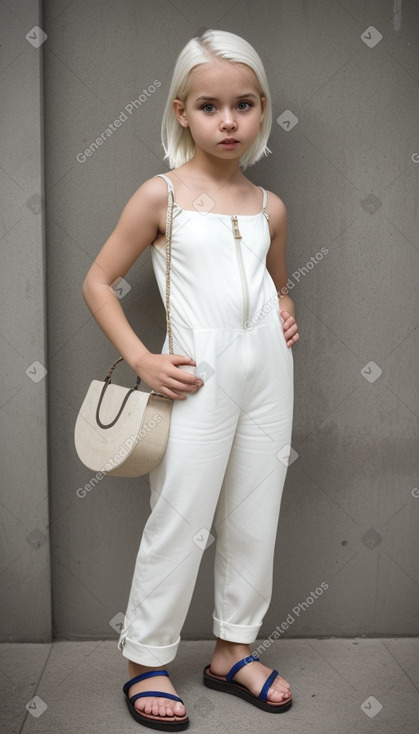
118,176 -> 294,667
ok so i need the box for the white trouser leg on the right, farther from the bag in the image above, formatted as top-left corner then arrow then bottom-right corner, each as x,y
213,327 -> 293,644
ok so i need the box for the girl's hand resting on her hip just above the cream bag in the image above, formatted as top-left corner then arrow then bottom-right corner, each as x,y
135,352 -> 204,400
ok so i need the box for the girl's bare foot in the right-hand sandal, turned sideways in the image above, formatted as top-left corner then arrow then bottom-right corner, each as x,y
211,639 -> 292,703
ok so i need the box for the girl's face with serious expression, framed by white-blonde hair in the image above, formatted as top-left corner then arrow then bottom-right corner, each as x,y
173,59 -> 266,160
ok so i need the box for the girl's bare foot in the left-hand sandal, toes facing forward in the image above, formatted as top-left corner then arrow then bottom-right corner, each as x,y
128,660 -> 186,717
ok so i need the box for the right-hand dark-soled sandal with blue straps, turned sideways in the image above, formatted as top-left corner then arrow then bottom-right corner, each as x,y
204,655 -> 292,714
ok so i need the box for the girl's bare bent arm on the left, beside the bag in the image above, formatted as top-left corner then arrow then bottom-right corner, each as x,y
82,179 -> 203,400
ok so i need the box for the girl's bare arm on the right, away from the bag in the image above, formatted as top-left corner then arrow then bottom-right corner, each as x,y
266,192 -> 299,347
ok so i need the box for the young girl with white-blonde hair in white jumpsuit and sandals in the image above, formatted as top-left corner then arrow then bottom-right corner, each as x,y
83,31 -> 298,731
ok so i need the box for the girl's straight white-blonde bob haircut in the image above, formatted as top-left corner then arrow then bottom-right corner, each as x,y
161,30 -> 272,170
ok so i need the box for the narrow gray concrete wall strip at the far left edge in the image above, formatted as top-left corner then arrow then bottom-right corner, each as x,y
0,2 -> 51,642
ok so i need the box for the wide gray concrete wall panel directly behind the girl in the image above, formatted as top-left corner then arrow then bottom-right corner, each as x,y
0,0 -> 419,639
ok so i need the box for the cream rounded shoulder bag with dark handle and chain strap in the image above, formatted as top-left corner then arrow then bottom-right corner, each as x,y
74,180 -> 173,477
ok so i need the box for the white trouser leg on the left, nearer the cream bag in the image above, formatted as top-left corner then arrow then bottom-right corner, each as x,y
119,360 -> 243,667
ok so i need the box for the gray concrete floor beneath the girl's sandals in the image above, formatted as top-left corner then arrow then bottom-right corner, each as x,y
0,638 -> 419,734
